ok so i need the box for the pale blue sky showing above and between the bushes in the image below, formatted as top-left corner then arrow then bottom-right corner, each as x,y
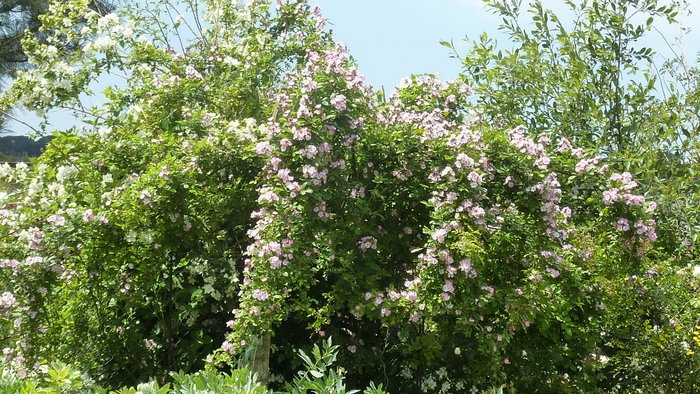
2,0 -> 700,133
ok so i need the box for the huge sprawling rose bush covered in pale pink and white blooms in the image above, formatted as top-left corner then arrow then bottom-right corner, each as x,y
0,0 -> 697,392
